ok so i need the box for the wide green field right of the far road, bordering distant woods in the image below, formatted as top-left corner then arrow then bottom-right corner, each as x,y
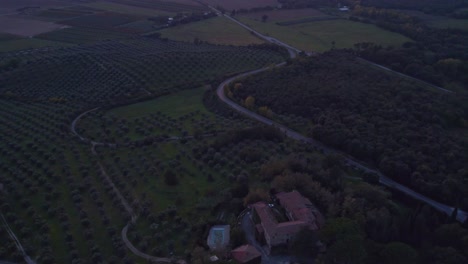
240,17 -> 411,52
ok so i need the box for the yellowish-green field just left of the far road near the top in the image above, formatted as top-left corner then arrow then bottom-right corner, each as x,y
160,17 -> 262,45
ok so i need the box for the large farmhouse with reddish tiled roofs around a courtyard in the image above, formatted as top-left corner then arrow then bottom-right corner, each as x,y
250,191 -> 323,248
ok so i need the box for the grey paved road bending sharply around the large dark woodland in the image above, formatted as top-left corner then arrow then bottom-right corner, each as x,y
216,63 -> 468,223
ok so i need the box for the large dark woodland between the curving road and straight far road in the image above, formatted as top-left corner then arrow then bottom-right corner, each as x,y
230,51 -> 468,211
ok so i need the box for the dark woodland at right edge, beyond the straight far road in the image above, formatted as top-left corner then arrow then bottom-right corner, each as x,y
351,6 -> 468,90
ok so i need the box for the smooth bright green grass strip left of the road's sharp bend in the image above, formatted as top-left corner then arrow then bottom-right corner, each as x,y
108,87 -> 208,118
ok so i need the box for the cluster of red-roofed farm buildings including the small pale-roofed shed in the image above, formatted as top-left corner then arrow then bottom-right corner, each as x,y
207,191 -> 324,263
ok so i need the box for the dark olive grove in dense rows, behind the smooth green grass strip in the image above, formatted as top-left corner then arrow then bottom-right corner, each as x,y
0,38 -> 284,102
